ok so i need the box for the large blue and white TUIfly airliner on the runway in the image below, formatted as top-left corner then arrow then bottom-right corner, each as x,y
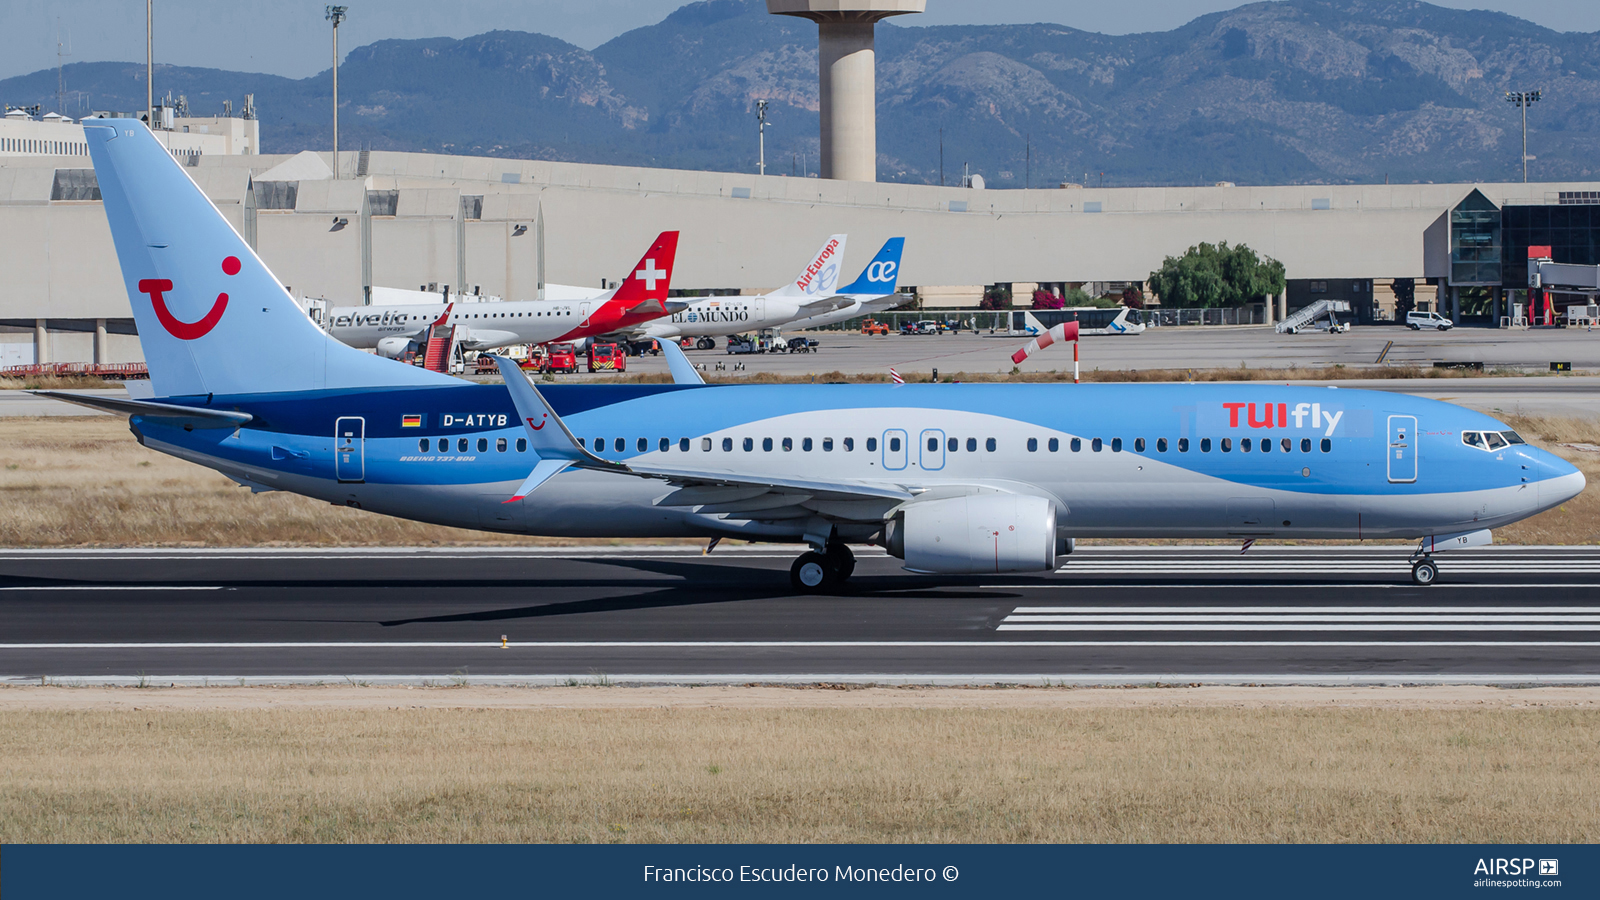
42,120 -> 1584,589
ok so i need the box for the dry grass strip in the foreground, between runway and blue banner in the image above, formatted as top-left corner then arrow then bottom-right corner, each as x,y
0,689 -> 1600,842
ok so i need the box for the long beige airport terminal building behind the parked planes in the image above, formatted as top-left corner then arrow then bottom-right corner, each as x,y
0,114 -> 1600,365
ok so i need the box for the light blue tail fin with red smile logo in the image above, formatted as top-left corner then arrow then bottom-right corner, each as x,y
83,119 -> 458,397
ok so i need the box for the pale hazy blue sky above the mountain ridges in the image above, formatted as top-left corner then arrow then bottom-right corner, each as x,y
0,0 -> 1600,82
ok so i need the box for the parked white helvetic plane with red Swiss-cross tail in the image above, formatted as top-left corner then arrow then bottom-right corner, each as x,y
328,231 -> 682,359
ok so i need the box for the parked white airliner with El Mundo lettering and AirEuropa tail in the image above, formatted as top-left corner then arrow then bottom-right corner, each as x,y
634,234 -> 853,351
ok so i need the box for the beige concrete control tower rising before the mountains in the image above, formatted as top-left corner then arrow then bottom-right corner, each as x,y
766,0 -> 928,181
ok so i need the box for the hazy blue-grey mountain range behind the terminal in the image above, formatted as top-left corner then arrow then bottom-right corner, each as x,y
0,0 -> 1600,187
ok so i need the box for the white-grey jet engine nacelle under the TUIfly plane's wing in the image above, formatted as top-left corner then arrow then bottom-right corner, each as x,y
885,493 -> 1058,575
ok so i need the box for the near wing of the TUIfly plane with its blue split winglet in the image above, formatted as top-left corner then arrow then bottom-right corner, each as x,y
494,356 -> 914,512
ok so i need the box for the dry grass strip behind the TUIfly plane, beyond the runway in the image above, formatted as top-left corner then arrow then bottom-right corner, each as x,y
0,416 -> 1600,548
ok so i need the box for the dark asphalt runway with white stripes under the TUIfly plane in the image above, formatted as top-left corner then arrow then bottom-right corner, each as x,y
0,546 -> 1600,684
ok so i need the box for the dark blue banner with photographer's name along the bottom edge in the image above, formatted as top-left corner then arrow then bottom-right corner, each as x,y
0,844 -> 1600,900
